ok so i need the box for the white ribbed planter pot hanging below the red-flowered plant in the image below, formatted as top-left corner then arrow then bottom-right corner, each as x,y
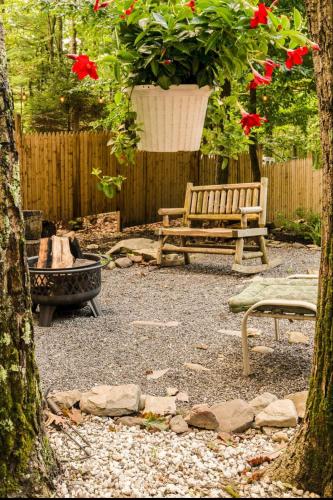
131,85 -> 212,152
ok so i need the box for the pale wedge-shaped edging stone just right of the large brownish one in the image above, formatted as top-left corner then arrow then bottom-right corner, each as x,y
255,399 -> 298,427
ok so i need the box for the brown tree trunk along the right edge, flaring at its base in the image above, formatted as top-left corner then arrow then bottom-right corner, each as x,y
274,0 -> 333,497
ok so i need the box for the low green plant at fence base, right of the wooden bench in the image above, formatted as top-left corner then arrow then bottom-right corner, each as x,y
277,208 -> 321,246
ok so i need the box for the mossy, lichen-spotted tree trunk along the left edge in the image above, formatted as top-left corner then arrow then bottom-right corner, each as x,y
0,18 -> 54,498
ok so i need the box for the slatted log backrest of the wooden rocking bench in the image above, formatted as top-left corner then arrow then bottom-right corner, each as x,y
184,177 -> 268,227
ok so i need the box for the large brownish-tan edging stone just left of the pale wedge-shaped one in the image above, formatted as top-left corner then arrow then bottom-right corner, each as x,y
211,399 -> 254,432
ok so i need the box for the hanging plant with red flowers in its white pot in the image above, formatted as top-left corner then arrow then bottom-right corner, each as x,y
68,0 -> 319,157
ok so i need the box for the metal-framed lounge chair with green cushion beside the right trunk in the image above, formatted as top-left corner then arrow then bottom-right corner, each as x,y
229,274 -> 318,376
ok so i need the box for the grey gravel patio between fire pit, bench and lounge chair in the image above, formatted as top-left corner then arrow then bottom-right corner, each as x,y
36,247 -> 319,406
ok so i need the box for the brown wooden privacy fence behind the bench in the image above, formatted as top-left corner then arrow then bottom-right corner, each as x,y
17,132 -> 322,226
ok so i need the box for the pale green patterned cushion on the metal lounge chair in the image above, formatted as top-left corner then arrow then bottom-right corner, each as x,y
229,278 -> 318,313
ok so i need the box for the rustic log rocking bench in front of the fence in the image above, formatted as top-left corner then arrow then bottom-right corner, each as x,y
157,177 -> 280,274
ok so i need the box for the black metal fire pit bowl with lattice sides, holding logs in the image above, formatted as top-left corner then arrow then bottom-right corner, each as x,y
28,253 -> 104,326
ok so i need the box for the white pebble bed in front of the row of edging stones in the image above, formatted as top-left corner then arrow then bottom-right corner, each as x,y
51,417 -> 318,498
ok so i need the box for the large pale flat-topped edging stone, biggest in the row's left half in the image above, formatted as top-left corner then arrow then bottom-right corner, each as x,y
80,384 -> 141,417
